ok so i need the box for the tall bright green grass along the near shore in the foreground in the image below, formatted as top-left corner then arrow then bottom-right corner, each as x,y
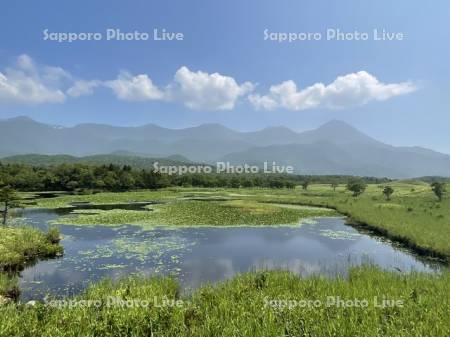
0,266 -> 450,337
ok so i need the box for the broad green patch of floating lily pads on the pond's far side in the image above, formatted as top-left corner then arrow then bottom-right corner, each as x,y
51,200 -> 336,226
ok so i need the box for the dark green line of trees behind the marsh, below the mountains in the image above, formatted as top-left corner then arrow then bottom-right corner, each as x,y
0,162 -> 389,191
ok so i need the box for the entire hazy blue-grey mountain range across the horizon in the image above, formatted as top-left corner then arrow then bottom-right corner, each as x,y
0,117 -> 450,178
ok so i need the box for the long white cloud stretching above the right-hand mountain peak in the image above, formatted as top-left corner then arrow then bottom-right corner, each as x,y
249,71 -> 417,111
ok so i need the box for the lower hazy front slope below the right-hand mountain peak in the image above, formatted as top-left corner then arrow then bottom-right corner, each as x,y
222,142 -> 450,178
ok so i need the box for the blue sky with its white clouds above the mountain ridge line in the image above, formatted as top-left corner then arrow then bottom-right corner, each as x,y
0,0 -> 450,153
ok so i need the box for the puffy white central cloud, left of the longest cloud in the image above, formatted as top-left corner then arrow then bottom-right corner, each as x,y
166,67 -> 254,110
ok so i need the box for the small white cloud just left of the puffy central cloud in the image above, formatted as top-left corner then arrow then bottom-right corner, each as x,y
103,72 -> 164,101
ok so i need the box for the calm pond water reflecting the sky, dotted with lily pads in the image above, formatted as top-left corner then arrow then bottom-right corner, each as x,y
14,205 -> 440,301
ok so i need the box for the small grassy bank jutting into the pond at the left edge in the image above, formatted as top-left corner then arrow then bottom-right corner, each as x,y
0,226 -> 63,272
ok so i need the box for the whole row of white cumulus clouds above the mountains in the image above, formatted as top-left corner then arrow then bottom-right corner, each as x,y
0,54 -> 417,111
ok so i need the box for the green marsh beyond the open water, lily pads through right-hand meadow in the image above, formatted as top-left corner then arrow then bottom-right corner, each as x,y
23,181 -> 450,260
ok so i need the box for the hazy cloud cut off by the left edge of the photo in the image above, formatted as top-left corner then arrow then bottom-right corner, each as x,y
0,54 -> 70,104
